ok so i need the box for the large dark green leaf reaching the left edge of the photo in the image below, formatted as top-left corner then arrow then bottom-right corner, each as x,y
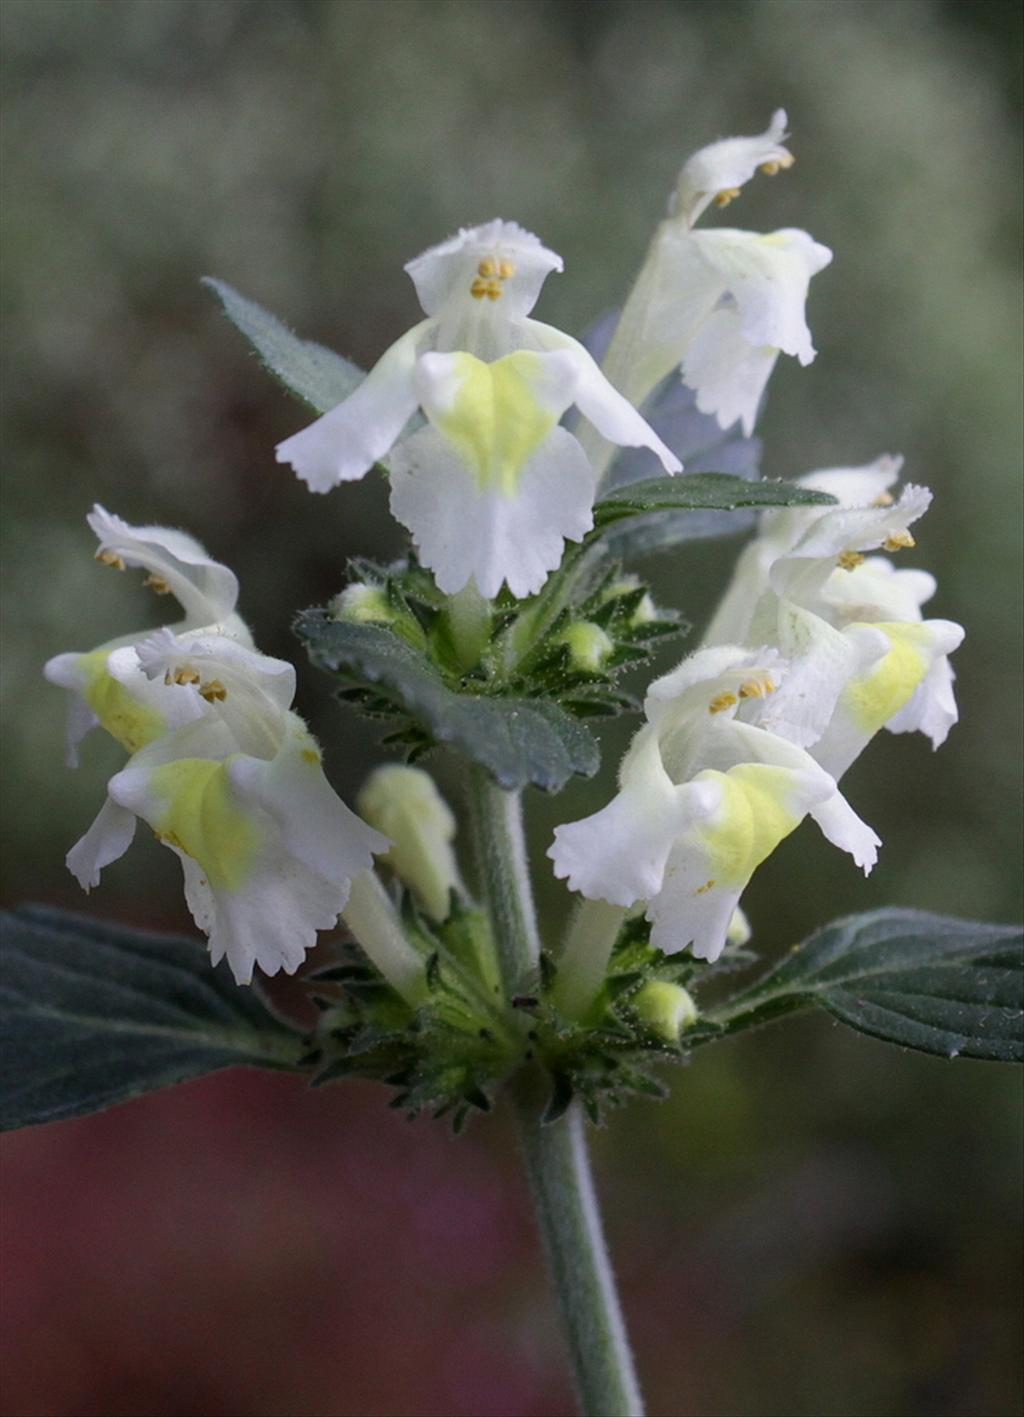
0,905 -> 302,1129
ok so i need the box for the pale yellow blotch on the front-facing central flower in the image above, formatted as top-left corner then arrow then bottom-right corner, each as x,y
432,350 -> 557,497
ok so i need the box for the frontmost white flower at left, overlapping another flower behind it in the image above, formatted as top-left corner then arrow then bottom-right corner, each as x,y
68,629 -> 388,983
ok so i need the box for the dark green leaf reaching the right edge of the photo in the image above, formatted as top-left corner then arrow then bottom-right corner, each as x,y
705,910 -> 1024,1063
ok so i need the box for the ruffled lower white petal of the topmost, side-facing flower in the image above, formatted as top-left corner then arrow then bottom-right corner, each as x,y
683,309 -> 779,438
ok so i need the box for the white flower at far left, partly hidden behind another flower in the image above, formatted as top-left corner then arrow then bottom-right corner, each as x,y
44,506 -> 252,768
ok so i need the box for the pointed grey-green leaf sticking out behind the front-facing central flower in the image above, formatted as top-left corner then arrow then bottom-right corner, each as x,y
203,275 -> 365,414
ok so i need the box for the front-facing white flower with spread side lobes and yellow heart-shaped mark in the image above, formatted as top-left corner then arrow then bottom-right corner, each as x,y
278,221 -> 680,597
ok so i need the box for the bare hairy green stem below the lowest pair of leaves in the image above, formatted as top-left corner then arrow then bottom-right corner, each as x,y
516,1078 -> 643,1417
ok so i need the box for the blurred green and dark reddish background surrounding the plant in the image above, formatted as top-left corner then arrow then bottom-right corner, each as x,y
1,0 -> 1021,1417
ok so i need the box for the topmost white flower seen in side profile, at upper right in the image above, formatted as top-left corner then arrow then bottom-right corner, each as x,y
605,109 -> 831,435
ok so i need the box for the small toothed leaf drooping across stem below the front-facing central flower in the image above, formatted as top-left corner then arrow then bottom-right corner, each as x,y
296,611 -> 599,792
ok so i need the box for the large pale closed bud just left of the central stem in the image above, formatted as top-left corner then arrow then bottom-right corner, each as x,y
355,764 -> 459,921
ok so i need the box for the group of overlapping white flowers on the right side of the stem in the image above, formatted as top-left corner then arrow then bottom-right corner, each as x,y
550,458 -> 963,959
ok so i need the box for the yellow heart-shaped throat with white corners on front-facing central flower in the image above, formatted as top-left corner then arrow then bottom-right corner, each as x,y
421,350 -> 574,497
